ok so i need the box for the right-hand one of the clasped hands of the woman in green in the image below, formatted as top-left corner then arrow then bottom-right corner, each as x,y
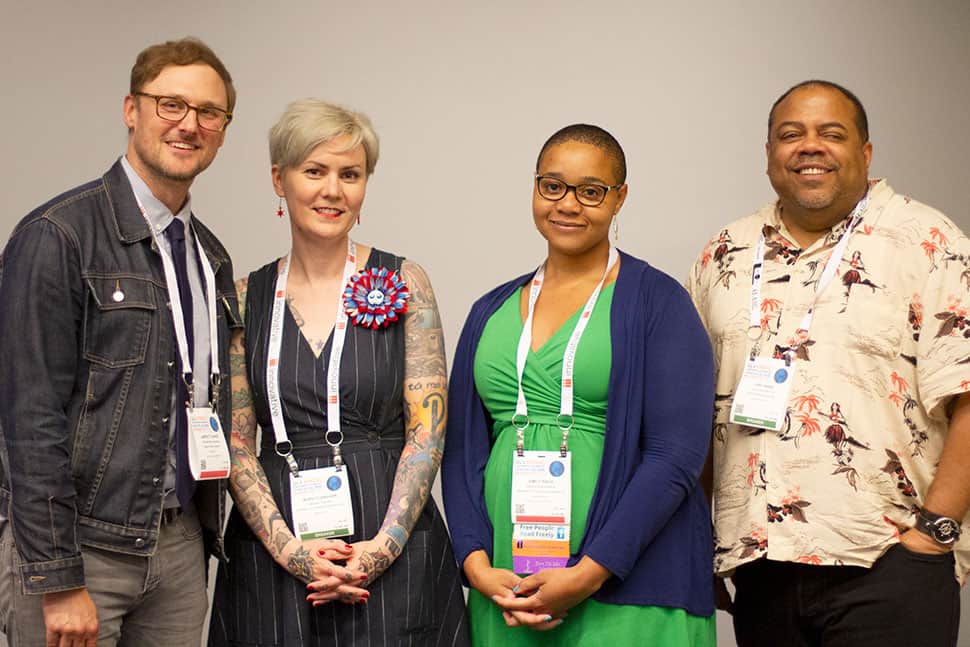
492,557 -> 610,630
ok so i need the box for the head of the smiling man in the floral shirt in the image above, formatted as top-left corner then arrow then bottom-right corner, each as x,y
765,85 -> 872,242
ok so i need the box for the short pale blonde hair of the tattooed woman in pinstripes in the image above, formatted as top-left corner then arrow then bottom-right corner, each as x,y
269,99 -> 380,175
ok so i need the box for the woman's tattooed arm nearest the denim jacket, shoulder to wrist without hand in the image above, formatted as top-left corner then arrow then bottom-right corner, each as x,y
229,279 -> 304,582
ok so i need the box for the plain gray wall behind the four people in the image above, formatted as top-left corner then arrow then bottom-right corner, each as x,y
0,0 -> 970,646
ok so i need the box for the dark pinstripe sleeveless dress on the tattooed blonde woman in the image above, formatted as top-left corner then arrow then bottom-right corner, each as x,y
209,249 -> 468,647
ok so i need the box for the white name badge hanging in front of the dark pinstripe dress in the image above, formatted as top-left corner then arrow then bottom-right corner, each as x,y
290,465 -> 354,541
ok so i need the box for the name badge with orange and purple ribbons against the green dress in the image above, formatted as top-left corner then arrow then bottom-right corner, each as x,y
512,451 -> 572,573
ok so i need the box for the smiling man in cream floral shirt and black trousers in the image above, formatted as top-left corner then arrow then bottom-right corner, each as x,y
688,81 -> 970,647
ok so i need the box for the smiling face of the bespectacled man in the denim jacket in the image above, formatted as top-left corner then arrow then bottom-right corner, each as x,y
124,63 -> 228,201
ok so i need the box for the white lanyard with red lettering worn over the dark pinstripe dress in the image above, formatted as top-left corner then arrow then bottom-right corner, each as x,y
266,239 -> 357,476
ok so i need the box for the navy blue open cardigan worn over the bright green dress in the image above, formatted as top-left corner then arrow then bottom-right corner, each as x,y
441,252 -> 714,616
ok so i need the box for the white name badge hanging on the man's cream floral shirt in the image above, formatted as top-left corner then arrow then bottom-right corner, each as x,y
731,357 -> 792,431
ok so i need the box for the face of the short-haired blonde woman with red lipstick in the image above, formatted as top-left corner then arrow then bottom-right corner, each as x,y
272,136 -> 367,246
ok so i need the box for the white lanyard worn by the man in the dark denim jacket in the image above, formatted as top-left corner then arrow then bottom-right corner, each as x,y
135,195 -> 222,409
